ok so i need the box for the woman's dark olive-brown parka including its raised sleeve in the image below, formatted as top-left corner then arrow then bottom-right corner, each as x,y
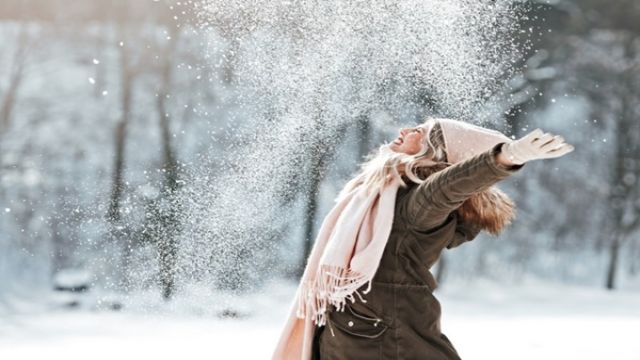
313,143 -> 523,360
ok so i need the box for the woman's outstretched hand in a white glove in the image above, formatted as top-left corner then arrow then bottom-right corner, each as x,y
497,129 -> 574,165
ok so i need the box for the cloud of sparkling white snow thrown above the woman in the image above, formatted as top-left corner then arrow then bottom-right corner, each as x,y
180,0 -> 521,288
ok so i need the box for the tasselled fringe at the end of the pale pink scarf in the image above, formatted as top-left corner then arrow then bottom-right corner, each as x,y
296,265 -> 371,326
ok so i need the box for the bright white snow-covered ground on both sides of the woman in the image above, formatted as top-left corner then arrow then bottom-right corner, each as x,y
0,283 -> 640,360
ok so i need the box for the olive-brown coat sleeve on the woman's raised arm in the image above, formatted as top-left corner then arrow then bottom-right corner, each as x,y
407,142 -> 524,230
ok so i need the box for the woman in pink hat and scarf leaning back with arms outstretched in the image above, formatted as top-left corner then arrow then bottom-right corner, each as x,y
273,119 -> 573,360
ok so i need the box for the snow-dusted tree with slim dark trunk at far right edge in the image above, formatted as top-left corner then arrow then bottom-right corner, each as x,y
569,30 -> 640,289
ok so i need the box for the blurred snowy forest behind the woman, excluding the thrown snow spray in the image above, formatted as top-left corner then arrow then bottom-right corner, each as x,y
0,0 -> 640,310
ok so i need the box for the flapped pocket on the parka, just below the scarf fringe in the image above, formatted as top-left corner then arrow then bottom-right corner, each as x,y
329,304 -> 389,339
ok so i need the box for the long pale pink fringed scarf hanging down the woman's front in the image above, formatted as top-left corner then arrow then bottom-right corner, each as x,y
273,176 -> 400,360
